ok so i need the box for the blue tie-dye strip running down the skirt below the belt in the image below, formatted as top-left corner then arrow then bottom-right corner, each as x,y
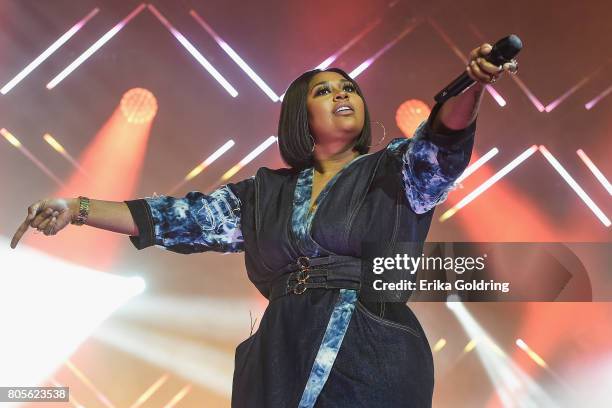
299,289 -> 357,408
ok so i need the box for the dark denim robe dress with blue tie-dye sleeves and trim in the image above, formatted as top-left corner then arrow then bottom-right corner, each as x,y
126,105 -> 475,408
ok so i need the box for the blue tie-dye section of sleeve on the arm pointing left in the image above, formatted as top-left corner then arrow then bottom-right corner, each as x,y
145,186 -> 244,254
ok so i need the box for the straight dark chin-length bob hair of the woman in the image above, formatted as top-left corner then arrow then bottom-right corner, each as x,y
278,68 -> 372,170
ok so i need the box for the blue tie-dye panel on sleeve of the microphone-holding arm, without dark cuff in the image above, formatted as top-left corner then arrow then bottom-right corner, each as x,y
387,122 -> 474,214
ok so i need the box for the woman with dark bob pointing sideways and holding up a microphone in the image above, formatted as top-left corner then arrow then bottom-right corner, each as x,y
11,44 -> 516,408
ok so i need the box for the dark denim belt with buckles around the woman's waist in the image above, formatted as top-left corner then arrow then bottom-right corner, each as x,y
269,255 -> 361,301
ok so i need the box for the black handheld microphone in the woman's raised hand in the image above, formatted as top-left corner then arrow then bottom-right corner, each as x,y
434,34 -> 523,103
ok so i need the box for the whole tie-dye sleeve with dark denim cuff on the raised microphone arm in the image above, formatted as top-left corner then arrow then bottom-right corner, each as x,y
387,105 -> 476,214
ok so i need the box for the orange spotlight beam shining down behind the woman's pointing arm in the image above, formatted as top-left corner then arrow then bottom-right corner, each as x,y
24,91 -> 156,271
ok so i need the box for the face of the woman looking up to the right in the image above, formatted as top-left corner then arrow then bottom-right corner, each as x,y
306,71 -> 365,148
